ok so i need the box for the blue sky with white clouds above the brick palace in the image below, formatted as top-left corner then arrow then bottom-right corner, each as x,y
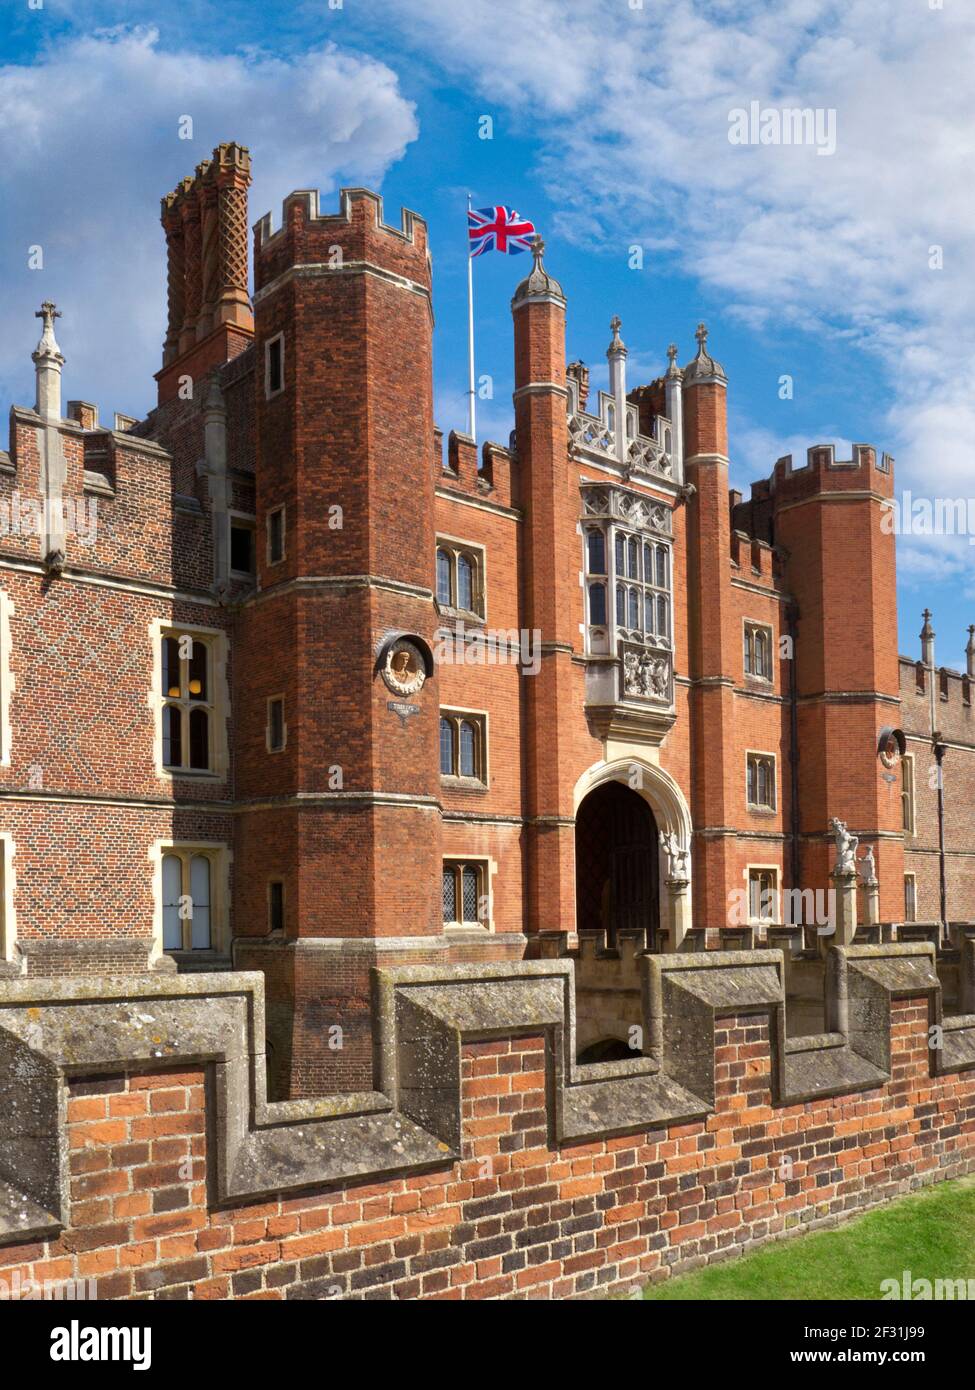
0,0 -> 975,666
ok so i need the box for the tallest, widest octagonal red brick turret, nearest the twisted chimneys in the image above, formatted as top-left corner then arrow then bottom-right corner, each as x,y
236,189 -> 442,1094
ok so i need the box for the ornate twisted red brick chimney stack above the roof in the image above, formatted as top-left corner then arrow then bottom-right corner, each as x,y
156,143 -> 255,404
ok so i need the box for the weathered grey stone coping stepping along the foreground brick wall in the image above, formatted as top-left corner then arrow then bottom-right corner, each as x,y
0,942 -> 975,1243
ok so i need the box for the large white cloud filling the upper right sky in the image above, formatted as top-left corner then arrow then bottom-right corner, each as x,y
389,0 -> 975,503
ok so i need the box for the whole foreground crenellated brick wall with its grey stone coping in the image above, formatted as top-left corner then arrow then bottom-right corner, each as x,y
0,944 -> 975,1298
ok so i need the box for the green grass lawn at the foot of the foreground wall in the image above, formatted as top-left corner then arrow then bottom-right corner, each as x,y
644,1177 -> 975,1300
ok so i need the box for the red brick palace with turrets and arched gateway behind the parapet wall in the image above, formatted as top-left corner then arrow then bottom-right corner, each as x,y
0,145 -> 975,1095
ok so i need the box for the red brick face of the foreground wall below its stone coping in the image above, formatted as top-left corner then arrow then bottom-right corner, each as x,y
0,997 -> 975,1298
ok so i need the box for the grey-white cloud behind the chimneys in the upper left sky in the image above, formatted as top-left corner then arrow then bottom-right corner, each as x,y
0,28 -> 417,416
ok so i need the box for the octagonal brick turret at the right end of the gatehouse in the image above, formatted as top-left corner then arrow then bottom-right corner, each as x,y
772,445 -> 904,920
